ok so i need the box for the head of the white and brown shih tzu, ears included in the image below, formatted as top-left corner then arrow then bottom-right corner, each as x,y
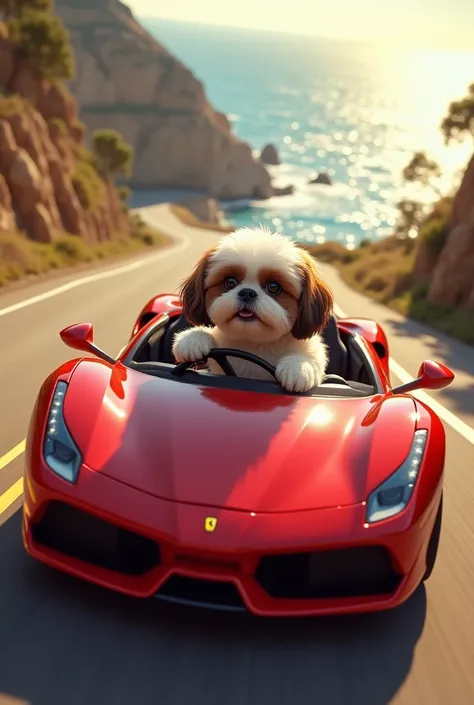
180,228 -> 332,343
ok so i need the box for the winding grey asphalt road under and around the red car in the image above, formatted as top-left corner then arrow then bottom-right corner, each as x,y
0,205 -> 474,705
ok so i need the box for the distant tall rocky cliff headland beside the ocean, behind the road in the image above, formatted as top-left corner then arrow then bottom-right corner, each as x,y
55,0 -> 272,198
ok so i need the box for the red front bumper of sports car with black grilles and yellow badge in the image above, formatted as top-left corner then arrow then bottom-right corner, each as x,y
23,456 -> 441,617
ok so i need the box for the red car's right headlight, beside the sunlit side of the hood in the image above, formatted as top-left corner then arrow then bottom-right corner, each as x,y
367,431 -> 428,524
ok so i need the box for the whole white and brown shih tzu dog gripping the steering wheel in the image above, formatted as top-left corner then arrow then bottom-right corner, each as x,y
173,228 -> 333,392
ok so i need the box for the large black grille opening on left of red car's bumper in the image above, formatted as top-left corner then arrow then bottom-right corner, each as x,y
32,501 -> 160,576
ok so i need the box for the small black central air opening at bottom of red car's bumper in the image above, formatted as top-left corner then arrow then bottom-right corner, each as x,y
155,575 -> 246,612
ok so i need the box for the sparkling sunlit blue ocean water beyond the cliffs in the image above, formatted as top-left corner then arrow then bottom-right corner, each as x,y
142,19 -> 474,249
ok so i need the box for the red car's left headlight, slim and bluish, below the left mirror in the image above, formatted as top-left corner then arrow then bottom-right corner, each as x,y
43,382 -> 82,482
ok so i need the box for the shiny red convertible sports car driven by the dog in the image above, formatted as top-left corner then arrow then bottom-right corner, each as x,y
23,294 -> 454,616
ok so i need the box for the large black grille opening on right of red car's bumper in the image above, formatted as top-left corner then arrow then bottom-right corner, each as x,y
255,546 -> 401,599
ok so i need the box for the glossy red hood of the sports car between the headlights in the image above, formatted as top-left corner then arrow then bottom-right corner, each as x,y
64,361 -> 416,512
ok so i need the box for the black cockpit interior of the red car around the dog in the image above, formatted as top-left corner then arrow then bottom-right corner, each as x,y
126,314 -> 381,397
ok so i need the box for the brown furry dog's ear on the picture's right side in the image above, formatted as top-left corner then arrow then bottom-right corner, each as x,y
291,250 -> 333,340
